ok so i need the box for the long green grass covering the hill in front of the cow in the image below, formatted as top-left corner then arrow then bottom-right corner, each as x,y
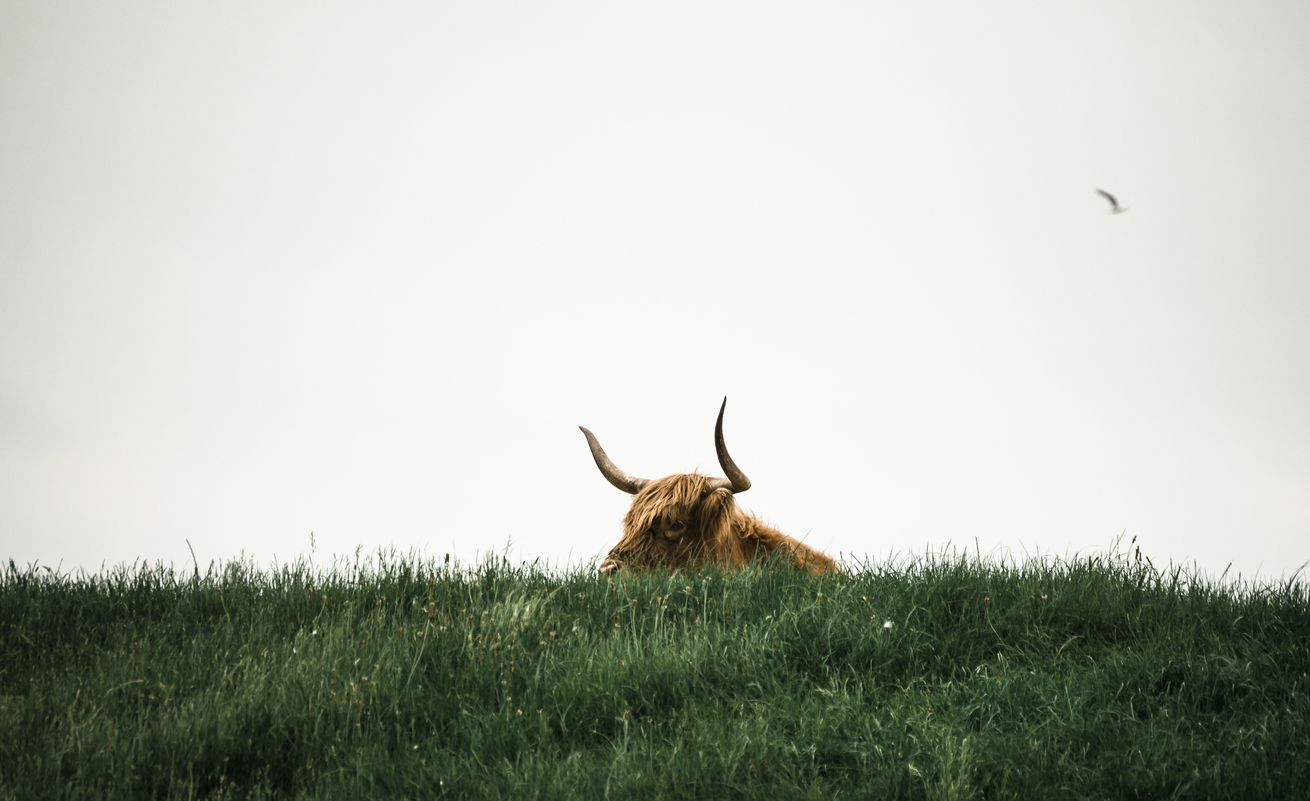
0,545 -> 1310,800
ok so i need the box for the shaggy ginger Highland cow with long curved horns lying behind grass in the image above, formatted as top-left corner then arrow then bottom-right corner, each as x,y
579,397 -> 840,573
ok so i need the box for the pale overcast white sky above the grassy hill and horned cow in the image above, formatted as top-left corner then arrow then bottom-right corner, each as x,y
0,0 -> 1310,587
